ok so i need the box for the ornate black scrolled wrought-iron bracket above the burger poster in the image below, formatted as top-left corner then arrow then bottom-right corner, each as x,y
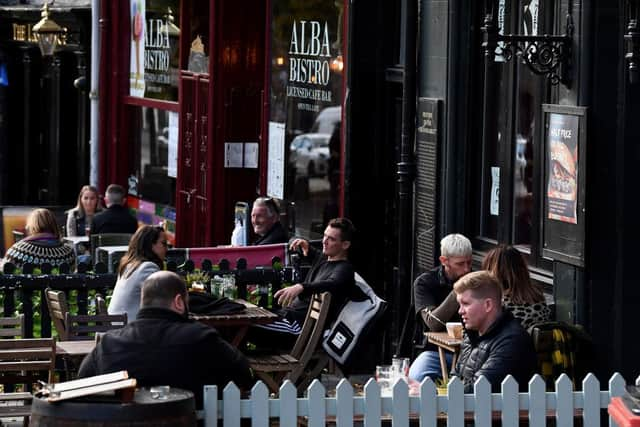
482,0 -> 574,86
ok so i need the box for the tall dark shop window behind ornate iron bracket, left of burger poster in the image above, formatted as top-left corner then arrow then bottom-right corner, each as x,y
469,0 -> 555,268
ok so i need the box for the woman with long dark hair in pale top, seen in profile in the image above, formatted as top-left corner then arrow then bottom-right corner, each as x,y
108,225 -> 167,321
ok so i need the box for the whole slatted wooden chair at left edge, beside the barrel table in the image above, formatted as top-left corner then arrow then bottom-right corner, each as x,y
0,338 -> 56,426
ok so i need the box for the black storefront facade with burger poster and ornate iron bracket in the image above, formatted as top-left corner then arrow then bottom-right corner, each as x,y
404,0 -> 640,378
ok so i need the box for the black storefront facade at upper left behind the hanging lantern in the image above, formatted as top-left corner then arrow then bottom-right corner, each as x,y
0,0 -> 91,206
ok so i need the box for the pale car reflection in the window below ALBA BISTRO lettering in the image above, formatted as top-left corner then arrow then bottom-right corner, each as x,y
289,133 -> 331,177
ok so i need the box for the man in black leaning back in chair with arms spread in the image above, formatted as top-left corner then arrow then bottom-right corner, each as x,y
249,218 -> 366,348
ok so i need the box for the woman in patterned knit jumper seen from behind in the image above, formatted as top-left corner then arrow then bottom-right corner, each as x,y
2,209 -> 76,271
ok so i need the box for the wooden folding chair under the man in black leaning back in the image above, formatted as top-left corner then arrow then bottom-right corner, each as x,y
249,292 -> 331,392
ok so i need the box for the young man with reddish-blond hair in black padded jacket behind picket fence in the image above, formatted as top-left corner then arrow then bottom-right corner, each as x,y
452,271 -> 536,393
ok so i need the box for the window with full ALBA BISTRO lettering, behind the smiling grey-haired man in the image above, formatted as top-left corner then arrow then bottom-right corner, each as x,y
267,0 -> 344,238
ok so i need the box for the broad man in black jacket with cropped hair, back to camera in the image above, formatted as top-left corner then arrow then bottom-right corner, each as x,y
78,271 -> 253,408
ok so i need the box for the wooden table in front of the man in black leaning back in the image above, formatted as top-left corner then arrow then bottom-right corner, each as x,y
189,300 -> 278,347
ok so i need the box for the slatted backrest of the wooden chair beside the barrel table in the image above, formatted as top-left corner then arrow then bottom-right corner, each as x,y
0,338 -> 56,389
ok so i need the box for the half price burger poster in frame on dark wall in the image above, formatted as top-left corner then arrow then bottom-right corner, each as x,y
547,113 -> 579,224
